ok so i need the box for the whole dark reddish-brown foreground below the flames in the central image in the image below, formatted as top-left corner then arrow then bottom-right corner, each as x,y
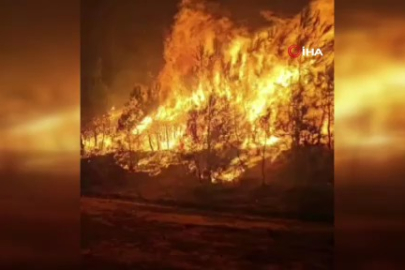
81,153 -> 334,270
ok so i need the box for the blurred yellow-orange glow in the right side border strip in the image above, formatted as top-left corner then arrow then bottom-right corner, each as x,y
335,14 -> 405,155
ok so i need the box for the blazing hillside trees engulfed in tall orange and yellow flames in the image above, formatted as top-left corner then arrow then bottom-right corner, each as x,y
82,0 -> 334,184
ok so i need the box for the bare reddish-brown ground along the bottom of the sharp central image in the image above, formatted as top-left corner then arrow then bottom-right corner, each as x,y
81,197 -> 333,270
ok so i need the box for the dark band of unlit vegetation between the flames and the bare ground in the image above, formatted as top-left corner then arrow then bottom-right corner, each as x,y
81,148 -> 333,222
